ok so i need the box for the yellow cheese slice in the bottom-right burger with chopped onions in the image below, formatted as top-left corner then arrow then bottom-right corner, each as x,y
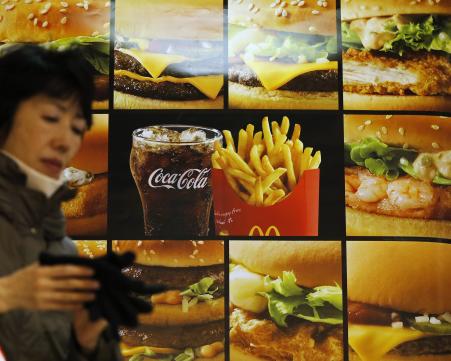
348,324 -> 428,361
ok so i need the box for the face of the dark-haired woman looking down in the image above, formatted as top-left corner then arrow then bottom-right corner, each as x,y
3,94 -> 86,179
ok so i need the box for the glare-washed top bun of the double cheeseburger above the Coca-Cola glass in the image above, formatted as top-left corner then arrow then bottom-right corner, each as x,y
115,0 -> 223,40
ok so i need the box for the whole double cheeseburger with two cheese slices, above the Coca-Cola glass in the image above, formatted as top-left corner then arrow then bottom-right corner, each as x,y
114,0 -> 224,109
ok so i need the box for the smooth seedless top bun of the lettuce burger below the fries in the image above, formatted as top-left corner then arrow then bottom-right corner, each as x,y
229,241 -> 341,287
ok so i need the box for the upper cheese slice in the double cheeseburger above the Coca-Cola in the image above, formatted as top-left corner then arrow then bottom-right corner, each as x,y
119,49 -> 187,78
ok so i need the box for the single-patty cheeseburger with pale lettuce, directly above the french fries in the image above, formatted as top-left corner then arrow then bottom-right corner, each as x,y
229,0 -> 338,109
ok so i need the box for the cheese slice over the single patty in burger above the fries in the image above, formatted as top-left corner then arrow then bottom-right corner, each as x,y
242,56 -> 338,90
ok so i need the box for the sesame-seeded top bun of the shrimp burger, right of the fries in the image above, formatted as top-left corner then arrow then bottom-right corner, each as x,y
344,114 -> 451,153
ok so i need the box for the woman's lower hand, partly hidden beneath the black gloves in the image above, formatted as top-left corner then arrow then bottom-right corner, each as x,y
74,309 -> 108,354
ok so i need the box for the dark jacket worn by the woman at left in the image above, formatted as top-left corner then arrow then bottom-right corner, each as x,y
0,153 -> 120,361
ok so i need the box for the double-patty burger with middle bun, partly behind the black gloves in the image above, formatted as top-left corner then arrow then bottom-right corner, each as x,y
113,241 -> 225,361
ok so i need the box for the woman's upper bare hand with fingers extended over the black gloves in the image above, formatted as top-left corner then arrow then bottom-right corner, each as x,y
0,263 -> 100,313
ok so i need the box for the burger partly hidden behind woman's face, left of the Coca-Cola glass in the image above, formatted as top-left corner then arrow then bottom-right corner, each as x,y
62,114 -> 108,236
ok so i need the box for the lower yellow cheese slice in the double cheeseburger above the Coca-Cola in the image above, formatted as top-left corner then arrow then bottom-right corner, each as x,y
114,70 -> 224,99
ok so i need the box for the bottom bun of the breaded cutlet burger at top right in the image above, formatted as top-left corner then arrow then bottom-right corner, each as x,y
343,92 -> 451,112
